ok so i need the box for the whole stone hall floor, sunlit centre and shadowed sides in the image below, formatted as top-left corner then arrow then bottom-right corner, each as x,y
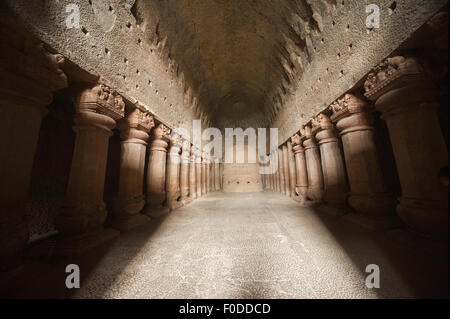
1,191 -> 448,298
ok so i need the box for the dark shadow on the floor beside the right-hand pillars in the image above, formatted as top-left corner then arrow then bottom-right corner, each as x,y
312,204 -> 449,298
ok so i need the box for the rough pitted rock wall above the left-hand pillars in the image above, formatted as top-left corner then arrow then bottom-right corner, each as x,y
2,0 -> 207,134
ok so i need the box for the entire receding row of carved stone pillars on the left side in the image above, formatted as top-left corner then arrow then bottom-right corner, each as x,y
0,41 -> 220,268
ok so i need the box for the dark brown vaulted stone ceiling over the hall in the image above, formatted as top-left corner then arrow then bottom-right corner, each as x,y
132,0 -> 330,127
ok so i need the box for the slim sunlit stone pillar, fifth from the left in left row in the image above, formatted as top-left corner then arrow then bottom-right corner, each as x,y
166,132 -> 181,210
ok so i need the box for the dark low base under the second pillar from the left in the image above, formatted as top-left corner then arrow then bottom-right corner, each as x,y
29,228 -> 120,257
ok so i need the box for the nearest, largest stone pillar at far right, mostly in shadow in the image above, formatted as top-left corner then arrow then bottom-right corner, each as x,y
364,57 -> 449,237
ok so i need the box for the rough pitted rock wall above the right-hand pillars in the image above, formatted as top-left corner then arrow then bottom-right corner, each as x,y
272,0 -> 447,143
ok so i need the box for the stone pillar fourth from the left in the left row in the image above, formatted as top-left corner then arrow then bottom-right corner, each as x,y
146,124 -> 170,217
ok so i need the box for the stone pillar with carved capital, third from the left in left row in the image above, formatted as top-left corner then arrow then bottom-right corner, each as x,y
110,108 -> 155,231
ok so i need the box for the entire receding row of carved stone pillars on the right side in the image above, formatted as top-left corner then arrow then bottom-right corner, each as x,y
265,57 -> 449,237
